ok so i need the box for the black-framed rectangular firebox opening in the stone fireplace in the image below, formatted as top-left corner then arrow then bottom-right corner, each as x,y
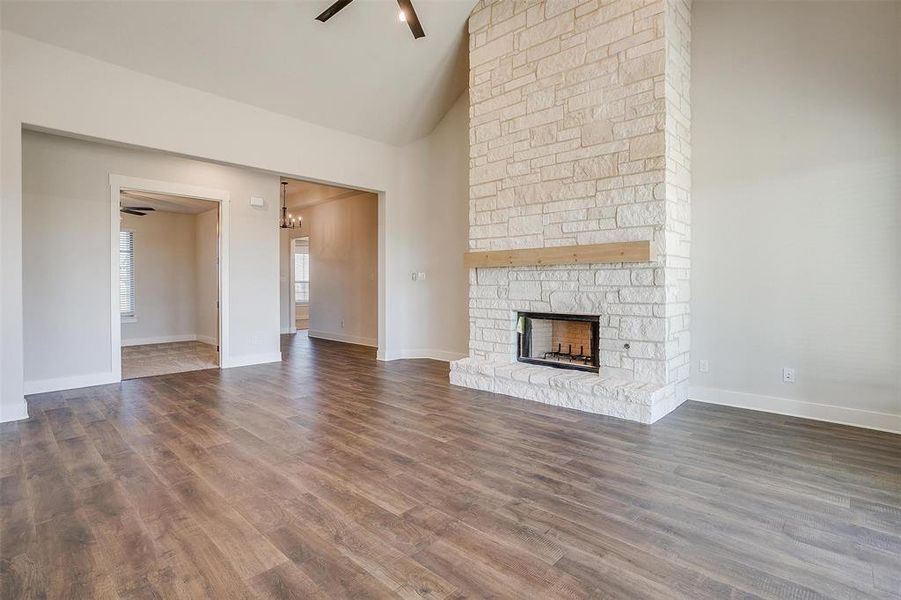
516,312 -> 600,373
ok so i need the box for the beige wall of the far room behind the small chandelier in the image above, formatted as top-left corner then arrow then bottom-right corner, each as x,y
281,193 -> 378,346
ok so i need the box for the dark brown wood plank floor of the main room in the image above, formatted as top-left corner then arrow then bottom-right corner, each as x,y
0,334 -> 901,600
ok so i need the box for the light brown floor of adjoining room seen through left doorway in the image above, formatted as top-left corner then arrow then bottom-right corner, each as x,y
122,342 -> 219,379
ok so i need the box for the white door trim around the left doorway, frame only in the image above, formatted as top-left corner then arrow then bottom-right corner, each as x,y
109,173 -> 231,381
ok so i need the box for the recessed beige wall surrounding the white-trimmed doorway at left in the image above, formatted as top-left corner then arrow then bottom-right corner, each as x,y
22,132 -> 280,389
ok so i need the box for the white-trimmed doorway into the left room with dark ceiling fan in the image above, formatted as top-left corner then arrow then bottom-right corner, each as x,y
110,176 -> 228,379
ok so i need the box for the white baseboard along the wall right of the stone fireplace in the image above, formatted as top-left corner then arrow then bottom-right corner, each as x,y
688,387 -> 901,433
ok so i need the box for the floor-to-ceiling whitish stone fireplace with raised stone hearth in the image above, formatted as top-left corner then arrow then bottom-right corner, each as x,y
451,0 -> 690,423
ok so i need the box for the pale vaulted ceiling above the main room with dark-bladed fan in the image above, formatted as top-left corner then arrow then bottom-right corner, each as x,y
0,0 -> 476,144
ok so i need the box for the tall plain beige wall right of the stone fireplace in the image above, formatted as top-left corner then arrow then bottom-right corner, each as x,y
691,2 -> 901,430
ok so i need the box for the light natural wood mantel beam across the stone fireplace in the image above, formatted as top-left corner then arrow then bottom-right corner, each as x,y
463,240 -> 654,269
